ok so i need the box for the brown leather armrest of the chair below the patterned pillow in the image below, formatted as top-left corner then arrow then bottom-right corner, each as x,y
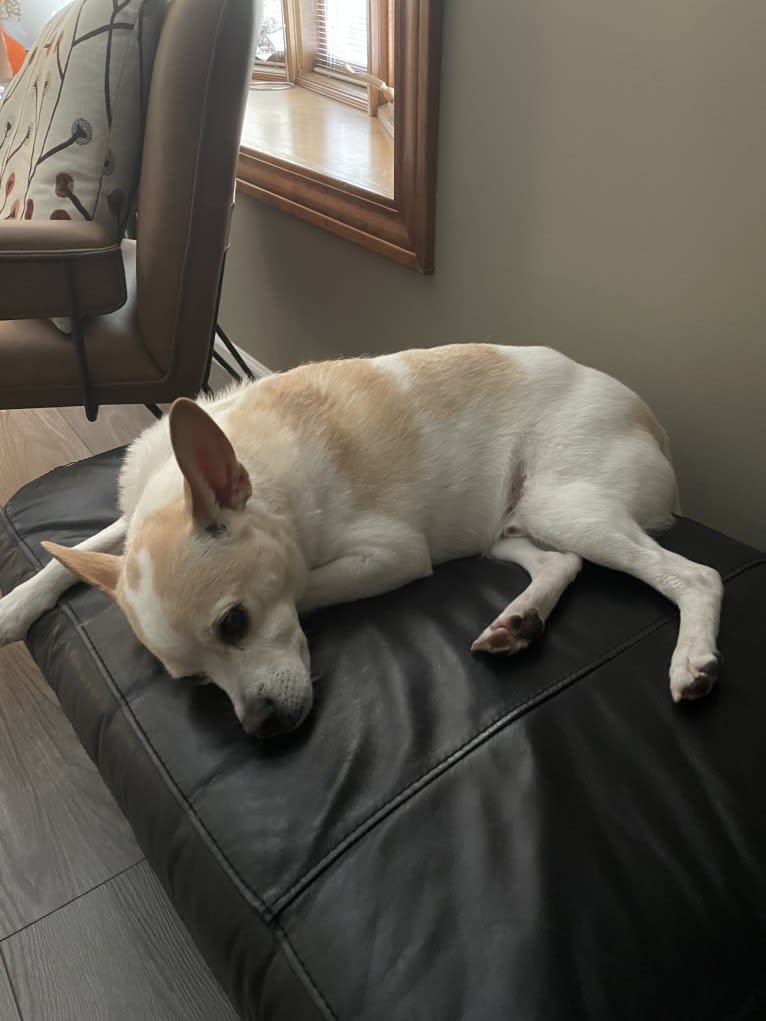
0,220 -> 127,320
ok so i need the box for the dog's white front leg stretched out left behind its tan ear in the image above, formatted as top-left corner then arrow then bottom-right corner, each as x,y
0,518 -> 128,645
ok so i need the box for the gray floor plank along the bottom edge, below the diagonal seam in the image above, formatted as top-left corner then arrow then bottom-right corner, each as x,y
0,862 -> 236,1021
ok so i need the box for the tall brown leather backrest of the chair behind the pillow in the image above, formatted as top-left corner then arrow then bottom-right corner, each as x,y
136,0 -> 253,392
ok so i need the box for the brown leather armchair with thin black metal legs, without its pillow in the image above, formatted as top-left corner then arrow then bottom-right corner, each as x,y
0,0 -> 253,419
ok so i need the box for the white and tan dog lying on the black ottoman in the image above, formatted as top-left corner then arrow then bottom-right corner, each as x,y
0,344 -> 722,736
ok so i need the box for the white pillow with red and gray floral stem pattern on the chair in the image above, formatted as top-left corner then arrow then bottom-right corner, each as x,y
0,0 -> 166,233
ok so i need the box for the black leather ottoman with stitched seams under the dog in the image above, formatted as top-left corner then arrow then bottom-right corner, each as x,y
0,451 -> 766,1021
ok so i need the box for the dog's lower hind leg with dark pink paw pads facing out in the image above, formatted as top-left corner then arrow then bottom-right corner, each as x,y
471,536 -> 582,655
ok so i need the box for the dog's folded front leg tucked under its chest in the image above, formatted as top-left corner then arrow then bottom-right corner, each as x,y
298,532 -> 433,613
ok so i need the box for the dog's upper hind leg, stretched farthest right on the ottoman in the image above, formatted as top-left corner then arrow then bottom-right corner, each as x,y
516,483 -> 723,701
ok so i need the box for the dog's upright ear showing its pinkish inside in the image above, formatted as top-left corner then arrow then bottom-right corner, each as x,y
171,397 -> 252,528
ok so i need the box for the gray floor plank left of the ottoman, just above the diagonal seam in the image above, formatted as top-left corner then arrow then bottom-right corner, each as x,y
0,643 -> 142,938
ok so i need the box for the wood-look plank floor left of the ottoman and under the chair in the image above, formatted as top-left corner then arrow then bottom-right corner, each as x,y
0,398 -> 236,1021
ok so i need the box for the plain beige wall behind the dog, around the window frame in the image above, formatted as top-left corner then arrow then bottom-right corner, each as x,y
222,0 -> 766,548
